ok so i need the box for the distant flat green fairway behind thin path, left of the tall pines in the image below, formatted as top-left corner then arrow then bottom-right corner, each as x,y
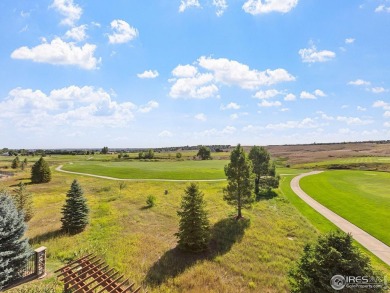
62,160 -> 229,180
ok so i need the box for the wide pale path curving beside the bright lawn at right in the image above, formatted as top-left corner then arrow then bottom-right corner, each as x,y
290,171 -> 390,266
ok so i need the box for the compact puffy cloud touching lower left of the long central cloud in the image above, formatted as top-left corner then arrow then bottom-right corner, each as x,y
169,73 -> 218,99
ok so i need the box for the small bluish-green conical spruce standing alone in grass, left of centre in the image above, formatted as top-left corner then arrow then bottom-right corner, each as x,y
61,179 -> 89,234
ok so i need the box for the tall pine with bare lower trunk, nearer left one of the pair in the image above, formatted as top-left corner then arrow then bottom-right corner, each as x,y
223,144 -> 254,219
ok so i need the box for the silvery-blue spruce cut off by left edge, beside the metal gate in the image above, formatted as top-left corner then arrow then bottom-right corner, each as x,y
0,191 -> 31,290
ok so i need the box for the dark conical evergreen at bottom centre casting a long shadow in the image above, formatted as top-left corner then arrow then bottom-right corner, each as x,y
175,183 -> 210,252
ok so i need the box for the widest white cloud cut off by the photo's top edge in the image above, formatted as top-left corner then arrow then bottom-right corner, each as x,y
242,0 -> 298,15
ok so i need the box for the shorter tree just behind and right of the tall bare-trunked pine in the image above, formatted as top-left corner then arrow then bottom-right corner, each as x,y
249,146 -> 279,196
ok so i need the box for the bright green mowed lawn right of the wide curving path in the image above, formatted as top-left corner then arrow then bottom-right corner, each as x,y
300,170 -> 390,245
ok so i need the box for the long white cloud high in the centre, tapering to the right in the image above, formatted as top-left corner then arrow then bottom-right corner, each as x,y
198,56 -> 295,89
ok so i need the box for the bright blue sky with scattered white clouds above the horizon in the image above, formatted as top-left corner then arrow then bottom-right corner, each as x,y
0,0 -> 390,148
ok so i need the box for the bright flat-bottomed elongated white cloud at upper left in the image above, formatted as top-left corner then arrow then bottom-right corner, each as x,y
11,38 -> 100,69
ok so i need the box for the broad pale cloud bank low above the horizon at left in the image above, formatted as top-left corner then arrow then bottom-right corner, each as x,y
0,86 -> 158,128
